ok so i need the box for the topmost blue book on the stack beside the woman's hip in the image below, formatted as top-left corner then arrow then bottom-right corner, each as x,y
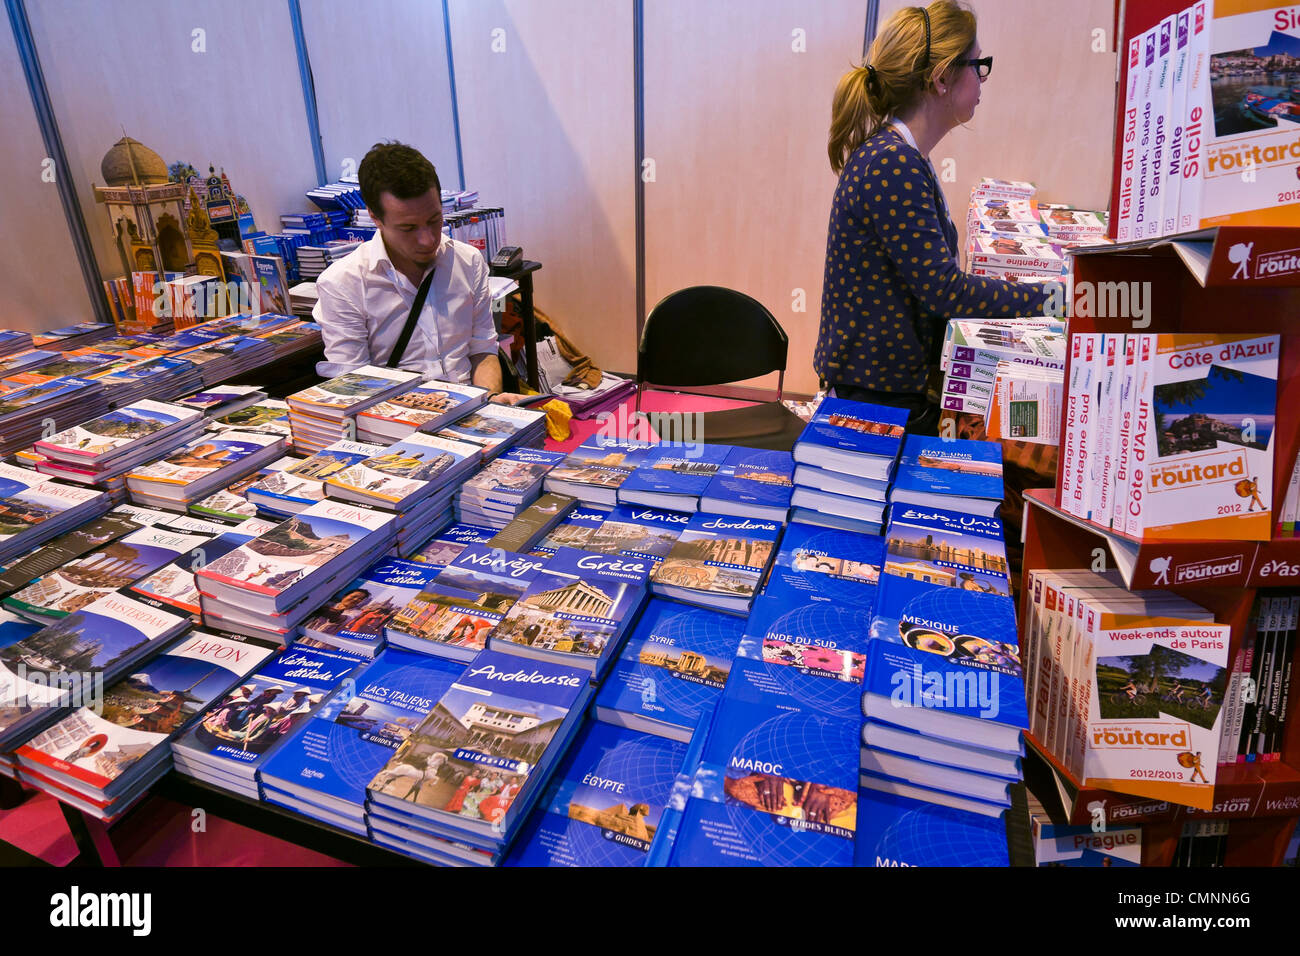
794,398 -> 907,480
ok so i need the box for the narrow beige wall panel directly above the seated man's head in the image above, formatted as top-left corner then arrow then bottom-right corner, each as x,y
299,0 -> 459,189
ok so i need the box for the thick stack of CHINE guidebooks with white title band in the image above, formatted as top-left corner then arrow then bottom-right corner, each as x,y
198,499 -> 395,639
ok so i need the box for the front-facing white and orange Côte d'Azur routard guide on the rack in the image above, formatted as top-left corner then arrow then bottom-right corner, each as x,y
1125,333 -> 1281,541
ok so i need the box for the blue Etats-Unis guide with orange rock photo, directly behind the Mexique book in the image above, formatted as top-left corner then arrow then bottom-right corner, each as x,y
871,505 -> 1011,640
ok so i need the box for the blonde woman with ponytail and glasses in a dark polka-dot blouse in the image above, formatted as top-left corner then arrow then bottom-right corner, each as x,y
814,0 -> 1047,434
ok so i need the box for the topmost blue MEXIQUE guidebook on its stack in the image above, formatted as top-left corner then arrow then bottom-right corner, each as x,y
862,588 -> 1028,753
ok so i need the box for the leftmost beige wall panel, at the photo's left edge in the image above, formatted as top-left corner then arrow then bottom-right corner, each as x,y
0,17 -> 95,332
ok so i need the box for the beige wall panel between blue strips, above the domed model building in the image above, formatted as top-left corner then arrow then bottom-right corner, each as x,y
27,0 -> 316,283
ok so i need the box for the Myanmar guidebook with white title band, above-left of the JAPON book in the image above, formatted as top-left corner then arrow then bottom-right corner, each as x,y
0,593 -> 190,750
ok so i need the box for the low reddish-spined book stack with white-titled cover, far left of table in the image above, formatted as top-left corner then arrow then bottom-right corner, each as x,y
33,399 -> 205,489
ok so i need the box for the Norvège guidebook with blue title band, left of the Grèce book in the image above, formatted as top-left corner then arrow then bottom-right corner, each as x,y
385,545 -> 546,661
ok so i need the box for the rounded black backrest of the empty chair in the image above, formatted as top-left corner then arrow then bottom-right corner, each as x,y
637,285 -> 790,386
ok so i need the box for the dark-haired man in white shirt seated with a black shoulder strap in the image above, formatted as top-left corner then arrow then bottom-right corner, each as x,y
312,143 -> 521,405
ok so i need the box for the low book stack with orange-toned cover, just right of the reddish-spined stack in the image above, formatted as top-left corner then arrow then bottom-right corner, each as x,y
126,429 -> 289,511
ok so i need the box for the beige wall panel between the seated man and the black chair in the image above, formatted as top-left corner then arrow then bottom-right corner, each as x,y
450,0 -> 636,372
